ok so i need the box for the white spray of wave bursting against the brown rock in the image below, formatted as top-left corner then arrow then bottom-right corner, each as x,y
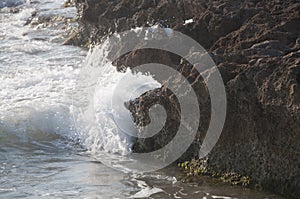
74,43 -> 161,155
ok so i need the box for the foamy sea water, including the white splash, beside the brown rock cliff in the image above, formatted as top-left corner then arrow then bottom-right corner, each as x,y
0,0 -> 281,199
